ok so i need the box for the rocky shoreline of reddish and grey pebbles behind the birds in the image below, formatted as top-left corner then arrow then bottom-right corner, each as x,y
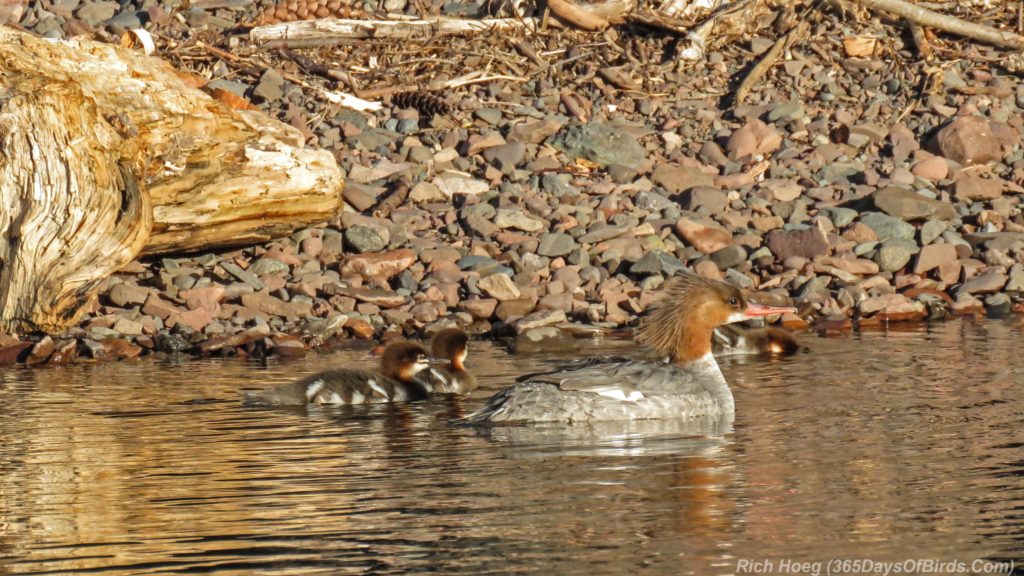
0,1 -> 1024,365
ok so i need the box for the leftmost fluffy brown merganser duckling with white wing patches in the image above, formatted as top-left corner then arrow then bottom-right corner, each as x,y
246,342 -> 444,406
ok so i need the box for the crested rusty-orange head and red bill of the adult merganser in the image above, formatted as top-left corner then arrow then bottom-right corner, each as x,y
636,273 -> 796,364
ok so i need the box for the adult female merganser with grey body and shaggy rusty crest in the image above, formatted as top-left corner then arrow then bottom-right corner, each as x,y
466,274 -> 795,423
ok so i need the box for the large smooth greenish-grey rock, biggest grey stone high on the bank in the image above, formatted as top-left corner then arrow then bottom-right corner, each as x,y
553,122 -> 647,169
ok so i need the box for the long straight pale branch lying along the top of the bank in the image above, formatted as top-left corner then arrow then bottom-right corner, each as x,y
249,18 -> 537,46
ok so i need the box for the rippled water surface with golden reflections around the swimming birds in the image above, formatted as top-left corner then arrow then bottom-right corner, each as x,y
0,321 -> 1024,575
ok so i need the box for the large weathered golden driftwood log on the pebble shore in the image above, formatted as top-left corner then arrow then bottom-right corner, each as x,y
0,27 -> 342,333
